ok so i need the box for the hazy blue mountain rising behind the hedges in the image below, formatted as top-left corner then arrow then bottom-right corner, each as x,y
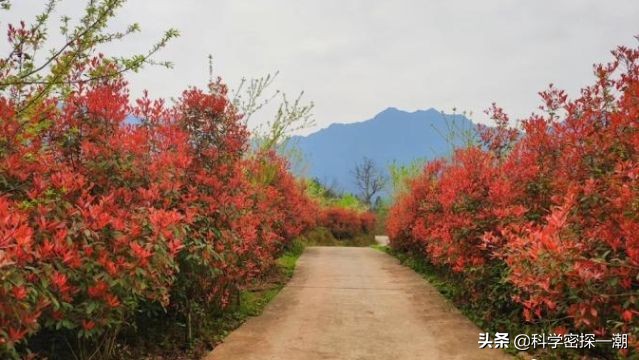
291,107 -> 473,197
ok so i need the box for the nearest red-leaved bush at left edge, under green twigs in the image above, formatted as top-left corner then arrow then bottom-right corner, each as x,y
0,58 -> 190,350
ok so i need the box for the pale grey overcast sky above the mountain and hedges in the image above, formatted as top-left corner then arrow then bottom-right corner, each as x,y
0,0 -> 639,133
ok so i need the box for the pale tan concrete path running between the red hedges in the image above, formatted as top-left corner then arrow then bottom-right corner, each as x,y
205,247 -> 508,360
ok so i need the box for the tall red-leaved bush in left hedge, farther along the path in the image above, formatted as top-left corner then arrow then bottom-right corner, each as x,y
132,80 -> 315,340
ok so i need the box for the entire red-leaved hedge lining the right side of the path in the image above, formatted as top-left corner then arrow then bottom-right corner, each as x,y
388,40 -> 639,352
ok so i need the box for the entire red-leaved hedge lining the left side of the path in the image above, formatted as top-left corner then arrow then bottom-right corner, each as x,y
0,57 -> 316,357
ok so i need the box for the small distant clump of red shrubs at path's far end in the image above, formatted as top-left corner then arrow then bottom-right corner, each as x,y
319,207 -> 375,239
